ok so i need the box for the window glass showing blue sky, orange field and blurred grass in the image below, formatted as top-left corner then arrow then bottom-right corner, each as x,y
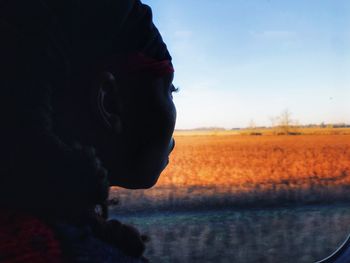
110,0 -> 350,262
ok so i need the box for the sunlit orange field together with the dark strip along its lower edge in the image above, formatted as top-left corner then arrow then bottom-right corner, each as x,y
112,135 -> 350,211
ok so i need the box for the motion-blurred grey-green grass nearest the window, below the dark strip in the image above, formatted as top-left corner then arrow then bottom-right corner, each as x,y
116,206 -> 350,263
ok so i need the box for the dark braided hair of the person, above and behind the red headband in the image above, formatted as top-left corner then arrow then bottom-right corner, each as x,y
0,0 -> 171,257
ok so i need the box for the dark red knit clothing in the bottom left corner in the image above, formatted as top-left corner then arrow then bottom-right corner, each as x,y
0,210 -> 63,263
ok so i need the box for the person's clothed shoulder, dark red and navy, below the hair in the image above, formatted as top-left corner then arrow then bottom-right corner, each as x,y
0,211 -> 147,263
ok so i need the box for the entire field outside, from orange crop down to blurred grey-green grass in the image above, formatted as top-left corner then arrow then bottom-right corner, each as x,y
110,134 -> 350,262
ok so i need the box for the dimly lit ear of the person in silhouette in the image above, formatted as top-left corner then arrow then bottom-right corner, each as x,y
91,71 -> 122,133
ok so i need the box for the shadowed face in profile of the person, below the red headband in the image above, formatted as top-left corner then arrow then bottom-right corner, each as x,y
97,73 -> 176,189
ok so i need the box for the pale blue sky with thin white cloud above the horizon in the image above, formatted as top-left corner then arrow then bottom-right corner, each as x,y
143,0 -> 350,129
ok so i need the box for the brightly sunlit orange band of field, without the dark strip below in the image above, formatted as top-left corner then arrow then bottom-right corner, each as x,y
158,135 -> 350,188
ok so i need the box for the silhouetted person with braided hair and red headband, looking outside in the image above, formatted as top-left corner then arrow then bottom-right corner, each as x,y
0,0 -> 176,262
